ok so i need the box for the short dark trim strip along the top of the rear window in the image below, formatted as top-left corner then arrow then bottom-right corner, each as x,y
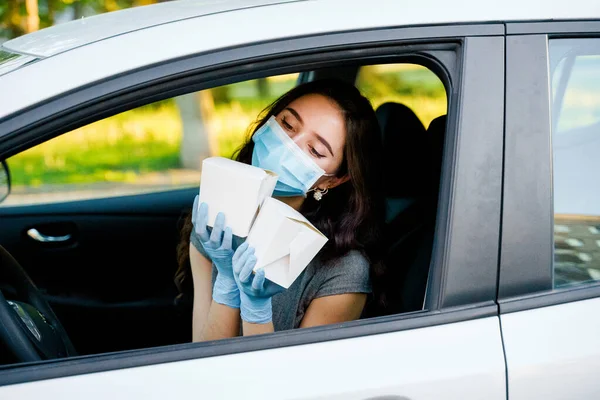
506,19 -> 600,36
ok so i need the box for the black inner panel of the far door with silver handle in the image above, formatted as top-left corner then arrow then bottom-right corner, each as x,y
0,184 -> 194,354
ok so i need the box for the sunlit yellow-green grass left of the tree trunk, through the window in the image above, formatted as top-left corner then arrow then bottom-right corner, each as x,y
8,106 -> 181,186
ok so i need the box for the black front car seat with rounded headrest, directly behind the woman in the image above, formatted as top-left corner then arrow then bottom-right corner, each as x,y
364,102 -> 429,317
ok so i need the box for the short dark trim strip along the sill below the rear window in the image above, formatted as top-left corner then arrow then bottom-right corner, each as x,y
499,282 -> 600,317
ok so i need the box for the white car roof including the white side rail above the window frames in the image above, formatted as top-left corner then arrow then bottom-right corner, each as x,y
0,0 -> 600,121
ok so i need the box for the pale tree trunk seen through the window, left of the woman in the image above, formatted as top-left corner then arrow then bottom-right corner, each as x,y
175,90 -> 216,169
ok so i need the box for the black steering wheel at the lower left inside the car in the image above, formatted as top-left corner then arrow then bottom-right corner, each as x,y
0,246 -> 77,362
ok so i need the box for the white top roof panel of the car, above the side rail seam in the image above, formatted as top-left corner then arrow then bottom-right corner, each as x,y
3,0 -> 600,58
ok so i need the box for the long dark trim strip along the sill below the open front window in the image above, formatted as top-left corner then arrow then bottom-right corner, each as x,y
0,302 -> 498,386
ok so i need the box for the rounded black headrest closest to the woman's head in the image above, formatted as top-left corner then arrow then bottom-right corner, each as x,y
375,102 -> 429,198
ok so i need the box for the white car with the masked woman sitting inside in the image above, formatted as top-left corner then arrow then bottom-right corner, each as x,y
0,0 -> 600,400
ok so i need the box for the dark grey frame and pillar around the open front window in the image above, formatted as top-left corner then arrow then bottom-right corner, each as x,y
0,24 -> 504,385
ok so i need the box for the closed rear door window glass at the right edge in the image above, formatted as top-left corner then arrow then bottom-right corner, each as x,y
550,39 -> 600,287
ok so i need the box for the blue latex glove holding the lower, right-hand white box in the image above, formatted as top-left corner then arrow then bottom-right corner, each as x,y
233,242 -> 285,324
